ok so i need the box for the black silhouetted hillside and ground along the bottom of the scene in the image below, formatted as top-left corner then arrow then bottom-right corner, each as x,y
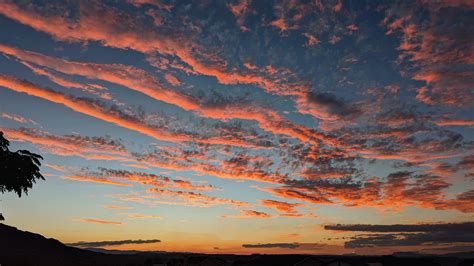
0,224 -> 474,266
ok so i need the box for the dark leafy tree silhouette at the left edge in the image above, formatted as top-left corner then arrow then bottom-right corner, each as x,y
0,131 -> 44,221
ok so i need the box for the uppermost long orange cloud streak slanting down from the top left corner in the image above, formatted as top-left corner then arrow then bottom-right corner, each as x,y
0,1 -> 308,98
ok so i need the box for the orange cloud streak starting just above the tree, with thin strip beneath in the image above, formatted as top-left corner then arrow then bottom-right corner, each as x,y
0,127 -> 284,186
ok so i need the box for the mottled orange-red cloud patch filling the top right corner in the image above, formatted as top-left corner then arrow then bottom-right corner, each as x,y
384,1 -> 474,106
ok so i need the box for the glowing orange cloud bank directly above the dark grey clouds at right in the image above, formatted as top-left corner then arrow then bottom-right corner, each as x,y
255,168 -> 474,214
